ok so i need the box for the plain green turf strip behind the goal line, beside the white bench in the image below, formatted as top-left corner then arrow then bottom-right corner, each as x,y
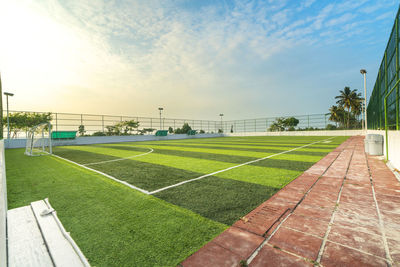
6,149 -> 226,266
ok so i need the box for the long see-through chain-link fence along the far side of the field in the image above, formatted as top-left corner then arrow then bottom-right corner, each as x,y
3,111 -> 335,138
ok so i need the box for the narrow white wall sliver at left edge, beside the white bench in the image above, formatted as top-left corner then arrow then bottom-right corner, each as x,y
0,140 -> 7,266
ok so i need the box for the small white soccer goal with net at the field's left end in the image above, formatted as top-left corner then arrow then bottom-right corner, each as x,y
25,122 -> 52,156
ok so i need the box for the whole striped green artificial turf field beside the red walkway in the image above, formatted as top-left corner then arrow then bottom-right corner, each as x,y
6,136 -> 347,266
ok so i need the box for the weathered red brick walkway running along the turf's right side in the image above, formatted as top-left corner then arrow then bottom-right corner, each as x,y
181,137 -> 400,267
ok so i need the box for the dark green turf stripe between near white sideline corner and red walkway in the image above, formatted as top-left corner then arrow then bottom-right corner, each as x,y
155,177 -> 279,225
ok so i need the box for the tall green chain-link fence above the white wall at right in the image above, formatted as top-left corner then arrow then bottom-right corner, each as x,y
367,9 -> 400,130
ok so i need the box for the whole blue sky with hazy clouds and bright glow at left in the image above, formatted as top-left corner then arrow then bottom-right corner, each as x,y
0,0 -> 399,120
